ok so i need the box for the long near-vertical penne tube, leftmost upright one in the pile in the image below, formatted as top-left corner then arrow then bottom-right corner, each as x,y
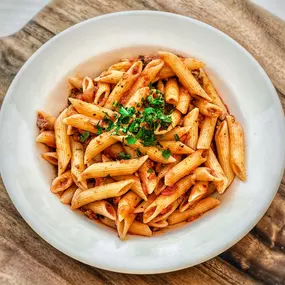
54,109 -> 71,175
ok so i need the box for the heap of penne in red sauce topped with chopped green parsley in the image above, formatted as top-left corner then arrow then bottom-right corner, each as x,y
36,51 -> 246,239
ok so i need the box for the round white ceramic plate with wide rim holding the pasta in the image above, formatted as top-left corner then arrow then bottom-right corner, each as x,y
0,11 -> 285,273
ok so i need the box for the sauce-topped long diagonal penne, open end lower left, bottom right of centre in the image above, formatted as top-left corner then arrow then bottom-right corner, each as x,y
143,172 -> 195,223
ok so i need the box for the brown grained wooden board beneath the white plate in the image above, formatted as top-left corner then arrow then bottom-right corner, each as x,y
0,0 -> 285,285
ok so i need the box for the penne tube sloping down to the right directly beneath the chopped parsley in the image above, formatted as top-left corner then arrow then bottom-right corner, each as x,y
113,136 -> 176,164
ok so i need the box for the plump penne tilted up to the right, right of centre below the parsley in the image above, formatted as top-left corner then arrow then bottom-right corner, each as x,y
164,150 -> 207,186
